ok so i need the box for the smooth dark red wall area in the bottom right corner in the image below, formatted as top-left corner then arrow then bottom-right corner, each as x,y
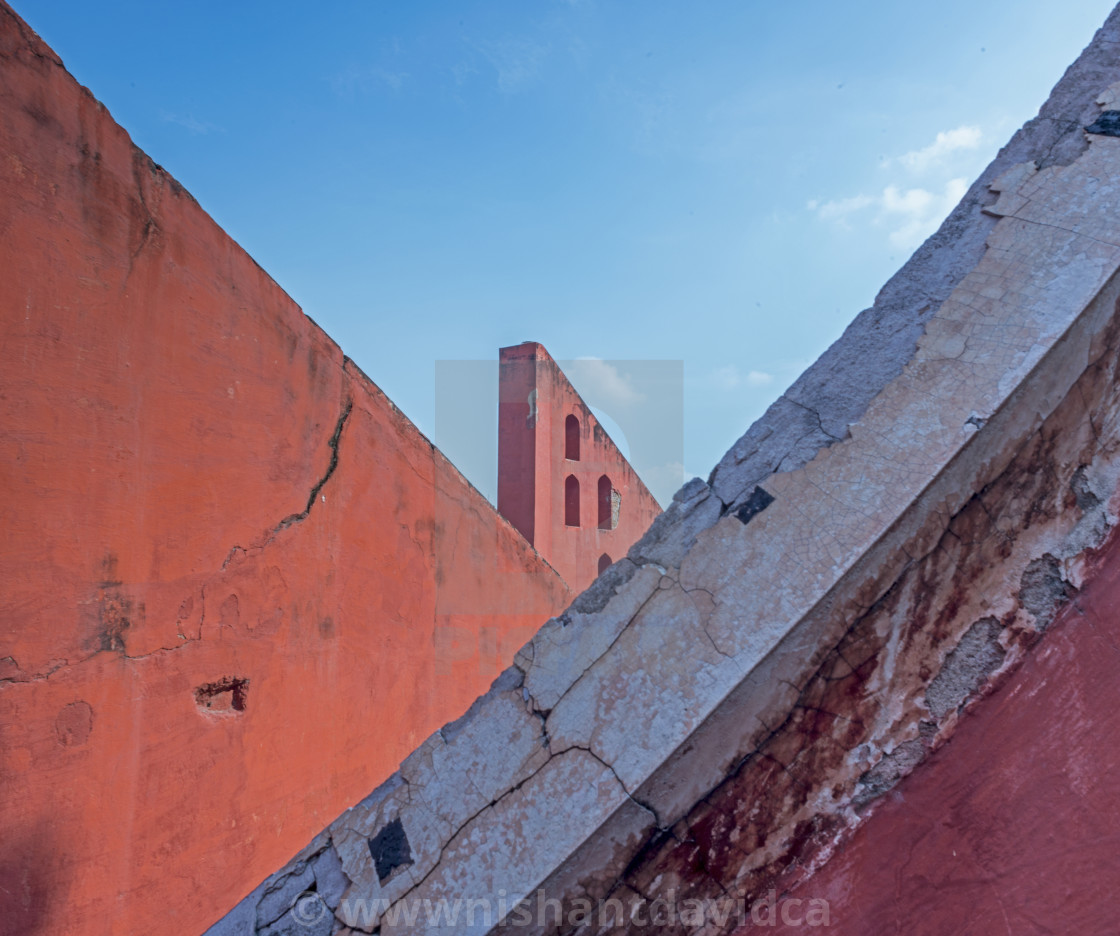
740,526 -> 1120,936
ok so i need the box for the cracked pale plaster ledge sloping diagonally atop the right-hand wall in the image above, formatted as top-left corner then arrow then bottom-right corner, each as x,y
213,3 -> 1120,933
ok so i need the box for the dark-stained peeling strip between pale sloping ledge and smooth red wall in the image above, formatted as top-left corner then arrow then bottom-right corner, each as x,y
604,276 -> 1120,933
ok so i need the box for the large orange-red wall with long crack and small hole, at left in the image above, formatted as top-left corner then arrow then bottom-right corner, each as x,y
0,4 -> 569,936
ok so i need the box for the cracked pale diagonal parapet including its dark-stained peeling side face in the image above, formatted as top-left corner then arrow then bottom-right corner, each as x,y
212,11 -> 1120,934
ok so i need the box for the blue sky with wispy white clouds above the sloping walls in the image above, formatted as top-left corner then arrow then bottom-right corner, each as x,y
16,0 -> 1111,496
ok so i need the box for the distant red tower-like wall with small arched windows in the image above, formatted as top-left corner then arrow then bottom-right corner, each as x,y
497,341 -> 661,592
